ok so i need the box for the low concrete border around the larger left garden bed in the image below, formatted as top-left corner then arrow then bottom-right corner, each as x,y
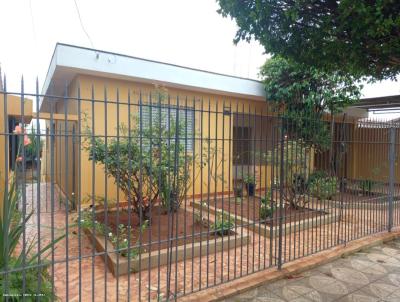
83,228 -> 251,277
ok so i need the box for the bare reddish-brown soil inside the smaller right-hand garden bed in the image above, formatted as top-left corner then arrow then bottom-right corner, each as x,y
203,196 -> 325,225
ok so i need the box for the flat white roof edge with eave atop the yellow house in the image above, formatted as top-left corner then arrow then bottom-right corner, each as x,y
40,43 -> 265,109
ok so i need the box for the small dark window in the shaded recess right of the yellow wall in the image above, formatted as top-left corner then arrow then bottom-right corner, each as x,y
233,126 -> 252,165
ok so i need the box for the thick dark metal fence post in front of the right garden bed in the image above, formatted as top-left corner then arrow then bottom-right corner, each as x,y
278,118 -> 285,269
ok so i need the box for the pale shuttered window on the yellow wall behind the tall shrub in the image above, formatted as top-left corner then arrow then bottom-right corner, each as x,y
142,105 -> 195,152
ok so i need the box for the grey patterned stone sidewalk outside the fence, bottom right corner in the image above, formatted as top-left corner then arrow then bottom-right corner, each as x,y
226,239 -> 400,302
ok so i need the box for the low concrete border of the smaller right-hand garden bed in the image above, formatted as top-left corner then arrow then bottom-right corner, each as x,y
191,201 -> 339,238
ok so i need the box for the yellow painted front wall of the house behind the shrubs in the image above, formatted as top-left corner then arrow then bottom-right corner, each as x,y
54,76 -> 278,204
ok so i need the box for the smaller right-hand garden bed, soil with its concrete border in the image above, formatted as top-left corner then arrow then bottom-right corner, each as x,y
192,197 -> 338,237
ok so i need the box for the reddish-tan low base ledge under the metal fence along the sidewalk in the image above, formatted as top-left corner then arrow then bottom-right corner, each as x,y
179,229 -> 400,302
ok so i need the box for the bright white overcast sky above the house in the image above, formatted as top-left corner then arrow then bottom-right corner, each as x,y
0,0 -> 400,117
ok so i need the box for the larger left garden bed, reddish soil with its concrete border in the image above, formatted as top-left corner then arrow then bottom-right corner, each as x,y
85,207 -> 250,276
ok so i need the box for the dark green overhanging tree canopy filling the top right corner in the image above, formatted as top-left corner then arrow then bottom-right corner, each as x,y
218,0 -> 400,79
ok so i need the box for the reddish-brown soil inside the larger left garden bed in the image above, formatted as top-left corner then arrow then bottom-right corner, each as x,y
96,206 -> 219,251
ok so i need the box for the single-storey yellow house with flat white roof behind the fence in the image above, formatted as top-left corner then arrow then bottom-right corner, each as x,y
40,44 -> 366,203
